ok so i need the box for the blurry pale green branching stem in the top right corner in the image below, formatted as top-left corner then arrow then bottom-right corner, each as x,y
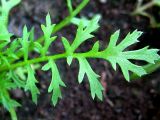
132,0 -> 160,27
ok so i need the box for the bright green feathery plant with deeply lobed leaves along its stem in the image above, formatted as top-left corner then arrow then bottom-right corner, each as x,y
0,0 -> 160,120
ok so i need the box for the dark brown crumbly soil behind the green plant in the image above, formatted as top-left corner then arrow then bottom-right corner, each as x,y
0,0 -> 160,120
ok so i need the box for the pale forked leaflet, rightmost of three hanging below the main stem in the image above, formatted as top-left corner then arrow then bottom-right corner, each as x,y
78,58 -> 104,100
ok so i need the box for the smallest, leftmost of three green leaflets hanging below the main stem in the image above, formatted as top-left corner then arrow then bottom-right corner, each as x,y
25,65 -> 40,104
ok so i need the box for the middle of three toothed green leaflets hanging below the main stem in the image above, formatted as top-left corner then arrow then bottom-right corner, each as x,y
42,60 -> 65,106
